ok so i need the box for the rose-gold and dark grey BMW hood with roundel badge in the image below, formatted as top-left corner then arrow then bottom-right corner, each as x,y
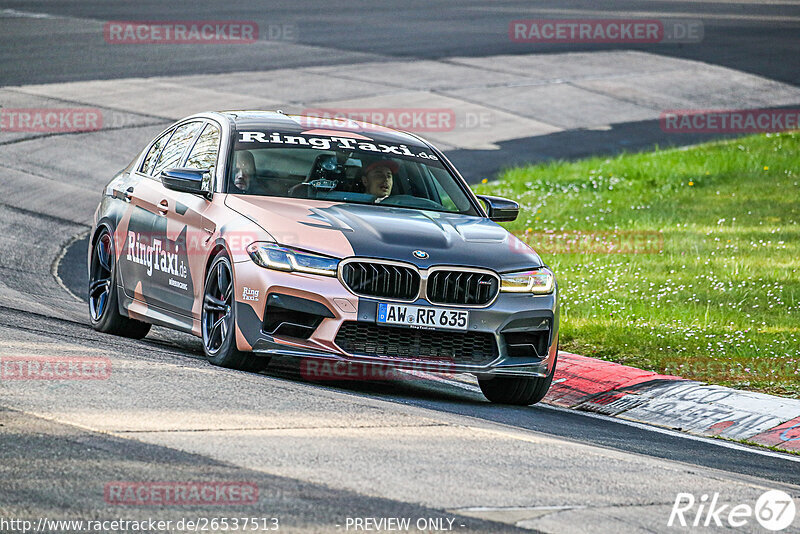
225,195 -> 542,272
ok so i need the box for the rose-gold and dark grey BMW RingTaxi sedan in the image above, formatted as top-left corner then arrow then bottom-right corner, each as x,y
88,111 -> 559,405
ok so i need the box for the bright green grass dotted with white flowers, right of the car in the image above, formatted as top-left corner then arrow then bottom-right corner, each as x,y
475,132 -> 800,398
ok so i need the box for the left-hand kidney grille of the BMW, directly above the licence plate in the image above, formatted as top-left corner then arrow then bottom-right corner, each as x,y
342,261 -> 420,300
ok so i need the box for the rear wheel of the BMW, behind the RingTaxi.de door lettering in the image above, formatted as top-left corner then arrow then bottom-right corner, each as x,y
89,229 -> 150,339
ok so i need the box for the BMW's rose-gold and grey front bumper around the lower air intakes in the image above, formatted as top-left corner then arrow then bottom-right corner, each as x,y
234,261 -> 559,377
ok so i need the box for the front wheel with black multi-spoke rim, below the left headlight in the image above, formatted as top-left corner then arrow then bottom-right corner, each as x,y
201,251 -> 269,373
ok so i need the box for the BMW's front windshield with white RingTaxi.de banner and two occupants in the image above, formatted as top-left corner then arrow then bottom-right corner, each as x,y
227,132 -> 477,215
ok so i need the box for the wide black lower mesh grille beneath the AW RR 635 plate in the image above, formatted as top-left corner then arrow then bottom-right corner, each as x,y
336,321 -> 497,365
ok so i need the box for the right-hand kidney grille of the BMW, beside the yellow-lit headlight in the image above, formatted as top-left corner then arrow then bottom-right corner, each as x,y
428,271 -> 500,306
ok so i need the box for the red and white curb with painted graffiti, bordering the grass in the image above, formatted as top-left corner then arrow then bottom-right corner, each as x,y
543,352 -> 800,451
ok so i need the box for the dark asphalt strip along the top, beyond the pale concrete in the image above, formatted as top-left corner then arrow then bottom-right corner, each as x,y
0,0 -> 800,85
